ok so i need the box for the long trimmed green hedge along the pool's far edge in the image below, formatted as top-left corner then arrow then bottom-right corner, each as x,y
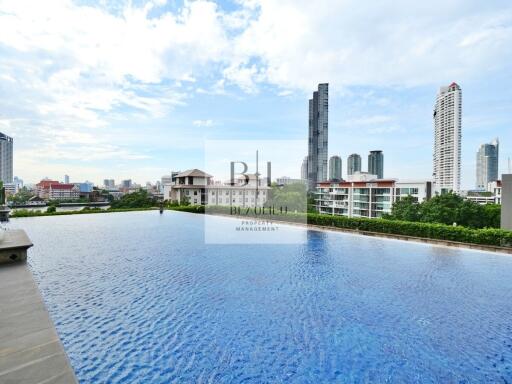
171,205 -> 512,247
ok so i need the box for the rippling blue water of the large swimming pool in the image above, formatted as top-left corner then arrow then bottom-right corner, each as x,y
10,212 -> 512,383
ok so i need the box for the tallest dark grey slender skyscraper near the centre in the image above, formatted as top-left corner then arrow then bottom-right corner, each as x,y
308,83 -> 329,190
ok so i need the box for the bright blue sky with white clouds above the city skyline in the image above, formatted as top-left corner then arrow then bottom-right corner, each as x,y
0,0 -> 512,187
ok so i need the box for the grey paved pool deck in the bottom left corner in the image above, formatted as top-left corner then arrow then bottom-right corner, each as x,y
0,262 -> 77,384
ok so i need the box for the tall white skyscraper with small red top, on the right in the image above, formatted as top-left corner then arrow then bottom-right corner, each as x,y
433,83 -> 462,193
